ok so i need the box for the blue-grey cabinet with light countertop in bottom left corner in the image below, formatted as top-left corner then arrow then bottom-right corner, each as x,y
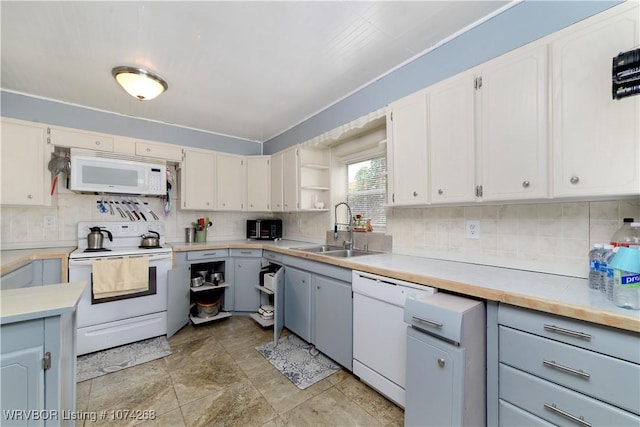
0,282 -> 86,426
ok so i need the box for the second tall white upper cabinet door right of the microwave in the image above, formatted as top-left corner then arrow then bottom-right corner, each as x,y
216,153 -> 247,211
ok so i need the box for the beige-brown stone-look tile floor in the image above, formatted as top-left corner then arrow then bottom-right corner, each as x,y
76,316 -> 404,427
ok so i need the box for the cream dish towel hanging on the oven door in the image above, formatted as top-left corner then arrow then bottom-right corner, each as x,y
93,257 -> 149,299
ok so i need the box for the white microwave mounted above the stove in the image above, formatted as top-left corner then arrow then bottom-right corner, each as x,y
69,148 -> 167,196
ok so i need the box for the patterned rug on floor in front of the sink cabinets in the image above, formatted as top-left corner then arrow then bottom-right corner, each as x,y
256,335 -> 341,390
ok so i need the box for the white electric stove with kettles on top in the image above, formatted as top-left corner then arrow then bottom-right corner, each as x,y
69,221 -> 172,355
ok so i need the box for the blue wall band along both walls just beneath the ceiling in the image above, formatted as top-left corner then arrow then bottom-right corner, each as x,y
0,0 -> 620,155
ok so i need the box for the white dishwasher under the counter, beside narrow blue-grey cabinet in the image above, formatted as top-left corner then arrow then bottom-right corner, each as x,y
352,271 -> 437,408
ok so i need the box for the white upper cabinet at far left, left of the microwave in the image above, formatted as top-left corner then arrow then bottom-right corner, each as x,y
0,119 -> 53,206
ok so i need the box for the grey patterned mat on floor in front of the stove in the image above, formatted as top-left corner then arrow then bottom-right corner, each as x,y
76,336 -> 171,382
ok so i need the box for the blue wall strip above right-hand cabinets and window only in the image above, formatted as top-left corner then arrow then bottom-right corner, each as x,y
264,1 -> 620,154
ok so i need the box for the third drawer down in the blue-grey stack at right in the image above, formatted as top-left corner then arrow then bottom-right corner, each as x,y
499,363 -> 640,427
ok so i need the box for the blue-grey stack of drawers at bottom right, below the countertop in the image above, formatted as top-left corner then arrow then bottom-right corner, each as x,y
497,304 -> 640,426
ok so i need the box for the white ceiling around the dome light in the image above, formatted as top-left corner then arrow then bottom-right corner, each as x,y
0,0 -> 508,141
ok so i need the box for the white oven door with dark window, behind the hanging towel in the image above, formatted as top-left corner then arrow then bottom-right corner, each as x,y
69,254 -> 171,328
